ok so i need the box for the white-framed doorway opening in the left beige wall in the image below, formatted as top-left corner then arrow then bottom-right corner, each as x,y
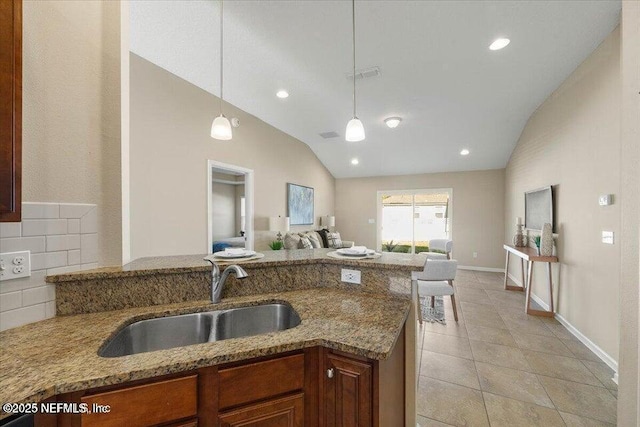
207,160 -> 254,254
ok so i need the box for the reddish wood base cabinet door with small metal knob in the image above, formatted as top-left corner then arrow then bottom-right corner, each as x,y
324,354 -> 373,427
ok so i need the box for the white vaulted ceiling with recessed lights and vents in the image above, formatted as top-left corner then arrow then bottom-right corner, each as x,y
130,0 -> 621,178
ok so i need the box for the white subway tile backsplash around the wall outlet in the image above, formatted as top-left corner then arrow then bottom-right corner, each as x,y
0,202 -> 98,331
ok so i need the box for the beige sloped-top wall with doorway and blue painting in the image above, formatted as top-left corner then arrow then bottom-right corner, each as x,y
130,54 -> 335,259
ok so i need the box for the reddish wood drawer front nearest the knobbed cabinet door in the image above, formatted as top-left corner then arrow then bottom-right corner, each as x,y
218,354 -> 304,409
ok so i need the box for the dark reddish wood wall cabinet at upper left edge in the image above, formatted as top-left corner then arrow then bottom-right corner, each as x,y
0,0 -> 22,222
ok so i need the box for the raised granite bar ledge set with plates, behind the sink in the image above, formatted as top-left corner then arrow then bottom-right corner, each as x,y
47,249 -> 426,283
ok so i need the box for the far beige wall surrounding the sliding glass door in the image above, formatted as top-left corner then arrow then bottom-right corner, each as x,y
336,169 -> 504,268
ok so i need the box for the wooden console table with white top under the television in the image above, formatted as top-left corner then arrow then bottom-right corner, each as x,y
504,245 -> 558,317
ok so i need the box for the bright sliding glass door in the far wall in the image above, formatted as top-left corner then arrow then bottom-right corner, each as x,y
378,188 -> 453,253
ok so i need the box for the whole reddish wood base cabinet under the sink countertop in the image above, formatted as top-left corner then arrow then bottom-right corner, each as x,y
53,336 -> 404,427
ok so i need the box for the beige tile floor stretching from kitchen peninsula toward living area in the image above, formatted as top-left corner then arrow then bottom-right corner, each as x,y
418,270 -> 617,427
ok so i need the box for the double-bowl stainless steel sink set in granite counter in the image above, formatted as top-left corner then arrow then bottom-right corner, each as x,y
98,304 -> 300,357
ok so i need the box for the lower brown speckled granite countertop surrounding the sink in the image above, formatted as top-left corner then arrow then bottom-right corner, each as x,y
0,288 -> 411,412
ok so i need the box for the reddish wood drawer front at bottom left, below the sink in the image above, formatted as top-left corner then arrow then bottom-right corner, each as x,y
81,375 -> 198,427
